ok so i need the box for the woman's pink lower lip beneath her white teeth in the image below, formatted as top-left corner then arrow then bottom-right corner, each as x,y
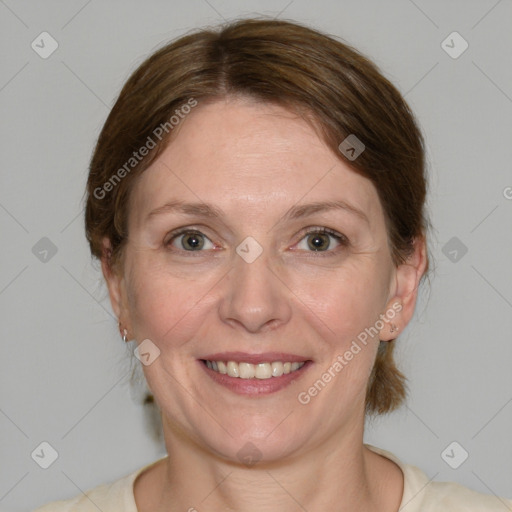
199,361 -> 313,395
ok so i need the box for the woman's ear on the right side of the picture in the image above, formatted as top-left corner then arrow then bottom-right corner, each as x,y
379,237 -> 428,341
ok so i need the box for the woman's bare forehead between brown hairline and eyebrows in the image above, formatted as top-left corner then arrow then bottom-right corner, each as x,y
128,99 -> 382,227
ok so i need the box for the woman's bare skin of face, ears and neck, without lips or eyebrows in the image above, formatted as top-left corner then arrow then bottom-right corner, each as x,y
103,98 -> 426,512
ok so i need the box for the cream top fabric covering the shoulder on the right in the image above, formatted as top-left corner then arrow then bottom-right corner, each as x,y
365,445 -> 512,512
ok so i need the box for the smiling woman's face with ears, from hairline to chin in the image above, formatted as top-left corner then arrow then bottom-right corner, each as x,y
104,99 -> 417,460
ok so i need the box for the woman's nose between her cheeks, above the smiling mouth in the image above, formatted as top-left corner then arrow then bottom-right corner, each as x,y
219,245 -> 292,333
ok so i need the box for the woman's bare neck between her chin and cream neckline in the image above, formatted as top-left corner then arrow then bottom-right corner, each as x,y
139,416 -> 403,512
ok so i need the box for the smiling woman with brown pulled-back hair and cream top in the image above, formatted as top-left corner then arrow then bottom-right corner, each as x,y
34,20 -> 512,512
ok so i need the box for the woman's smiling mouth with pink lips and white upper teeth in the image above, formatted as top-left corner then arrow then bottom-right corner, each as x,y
199,352 -> 313,396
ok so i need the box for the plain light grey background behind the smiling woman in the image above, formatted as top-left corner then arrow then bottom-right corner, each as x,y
0,0 -> 512,511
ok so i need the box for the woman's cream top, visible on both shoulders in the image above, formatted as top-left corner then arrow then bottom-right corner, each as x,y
34,444 -> 512,512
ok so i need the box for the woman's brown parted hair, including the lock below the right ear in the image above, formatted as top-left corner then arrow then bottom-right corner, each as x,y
85,19 -> 428,413
